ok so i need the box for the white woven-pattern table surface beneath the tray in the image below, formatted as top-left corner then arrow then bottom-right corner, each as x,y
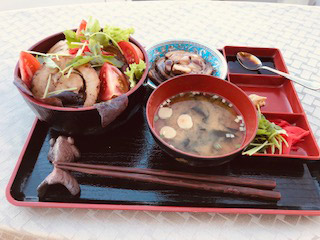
0,1 -> 320,240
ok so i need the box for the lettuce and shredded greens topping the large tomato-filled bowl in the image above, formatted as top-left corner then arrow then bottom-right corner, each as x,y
25,17 -> 146,99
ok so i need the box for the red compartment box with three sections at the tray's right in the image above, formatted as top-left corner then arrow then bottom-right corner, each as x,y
223,46 -> 320,160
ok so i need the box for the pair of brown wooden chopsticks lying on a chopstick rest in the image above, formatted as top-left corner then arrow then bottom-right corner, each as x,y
55,162 -> 281,201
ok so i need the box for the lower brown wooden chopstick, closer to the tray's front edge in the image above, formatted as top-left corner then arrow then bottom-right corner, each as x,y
56,163 -> 281,201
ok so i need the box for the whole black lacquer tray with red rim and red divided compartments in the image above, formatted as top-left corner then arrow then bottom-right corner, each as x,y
6,47 -> 320,215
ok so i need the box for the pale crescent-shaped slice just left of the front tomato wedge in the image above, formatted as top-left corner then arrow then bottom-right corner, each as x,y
78,64 -> 100,107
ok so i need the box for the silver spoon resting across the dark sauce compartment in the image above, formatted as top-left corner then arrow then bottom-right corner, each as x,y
237,52 -> 320,90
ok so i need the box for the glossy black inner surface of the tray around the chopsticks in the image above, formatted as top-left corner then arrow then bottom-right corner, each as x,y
11,94 -> 320,210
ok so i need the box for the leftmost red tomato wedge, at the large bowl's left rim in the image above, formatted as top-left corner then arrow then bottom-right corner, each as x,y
19,52 -> 41,88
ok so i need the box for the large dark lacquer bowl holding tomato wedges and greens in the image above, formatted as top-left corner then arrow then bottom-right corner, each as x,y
14,33 -> 149,135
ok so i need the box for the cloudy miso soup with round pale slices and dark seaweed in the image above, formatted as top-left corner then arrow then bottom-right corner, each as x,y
154,92 -> 245,156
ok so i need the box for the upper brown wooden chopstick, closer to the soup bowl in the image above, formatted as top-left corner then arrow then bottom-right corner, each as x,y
58,162 -> 276,189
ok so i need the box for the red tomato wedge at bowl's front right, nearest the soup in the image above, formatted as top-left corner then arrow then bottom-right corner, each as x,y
99,63 -> 129,101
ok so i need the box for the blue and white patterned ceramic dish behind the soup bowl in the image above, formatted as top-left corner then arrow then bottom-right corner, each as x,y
147,39 -> 228,79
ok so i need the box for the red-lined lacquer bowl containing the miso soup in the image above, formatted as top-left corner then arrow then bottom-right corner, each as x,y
147,74 -> 258,167
